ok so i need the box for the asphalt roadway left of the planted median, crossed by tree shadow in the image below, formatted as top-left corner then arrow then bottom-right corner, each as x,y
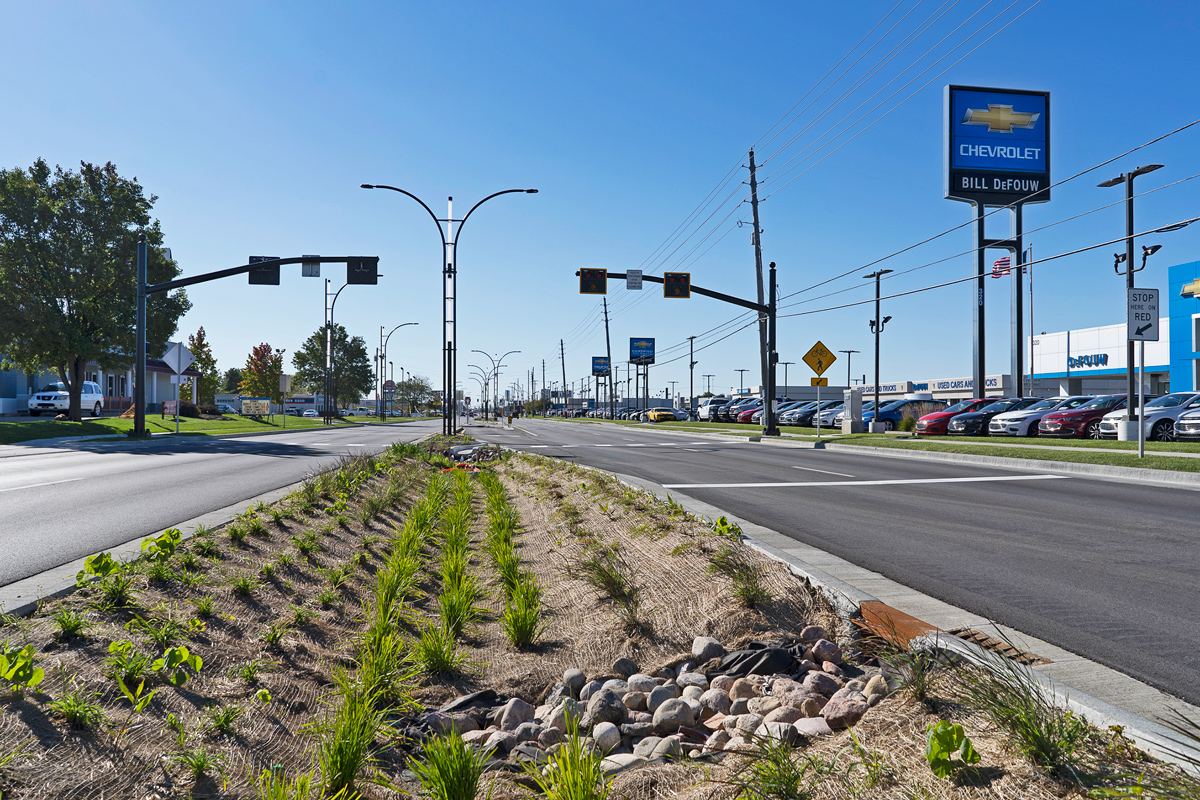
0,420 -> 442,585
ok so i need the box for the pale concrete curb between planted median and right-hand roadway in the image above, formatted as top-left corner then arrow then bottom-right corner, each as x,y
535,453 -> 1200,775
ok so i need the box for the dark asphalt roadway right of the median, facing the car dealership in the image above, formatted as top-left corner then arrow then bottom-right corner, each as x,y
472,420 -> 1200,704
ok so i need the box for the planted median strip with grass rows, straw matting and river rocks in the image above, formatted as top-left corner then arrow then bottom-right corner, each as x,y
0,441 -> 1198,800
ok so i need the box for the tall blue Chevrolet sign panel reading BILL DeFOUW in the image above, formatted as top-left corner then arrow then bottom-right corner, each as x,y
944,86 -> 1050,205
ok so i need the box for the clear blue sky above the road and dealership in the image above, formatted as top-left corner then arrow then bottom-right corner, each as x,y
0,0 -> 1200,393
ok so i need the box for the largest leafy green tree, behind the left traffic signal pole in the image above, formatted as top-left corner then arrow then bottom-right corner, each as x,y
0,158 -> 191,420
